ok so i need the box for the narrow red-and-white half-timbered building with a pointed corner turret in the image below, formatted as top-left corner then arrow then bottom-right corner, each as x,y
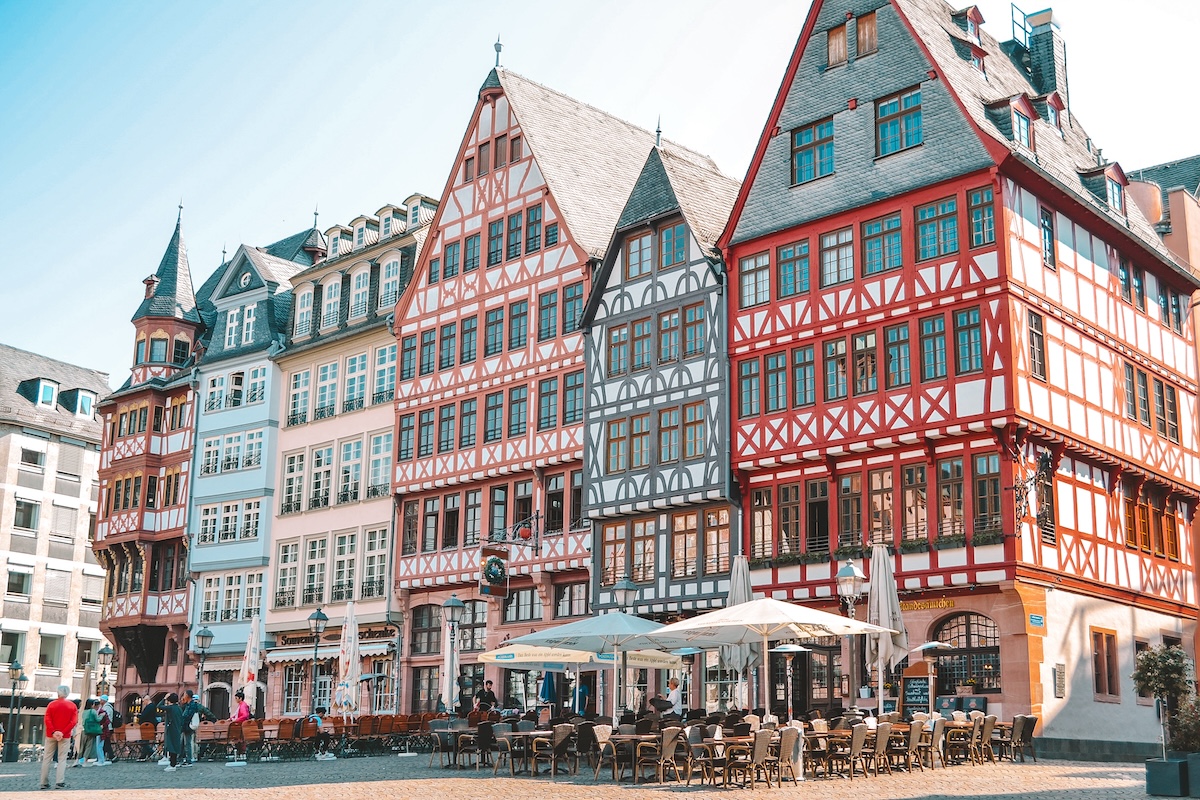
92,215 -> 205,717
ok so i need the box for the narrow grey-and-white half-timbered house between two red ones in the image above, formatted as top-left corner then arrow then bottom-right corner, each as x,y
583,144 -> 740,703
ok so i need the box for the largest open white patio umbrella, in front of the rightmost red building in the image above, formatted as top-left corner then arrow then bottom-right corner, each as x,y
626,597 -> 890,704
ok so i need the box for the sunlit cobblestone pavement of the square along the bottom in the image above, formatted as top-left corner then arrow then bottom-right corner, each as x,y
0,756 -> 1146,800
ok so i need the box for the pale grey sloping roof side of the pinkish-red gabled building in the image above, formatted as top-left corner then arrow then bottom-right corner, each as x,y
489,67 -> 716,257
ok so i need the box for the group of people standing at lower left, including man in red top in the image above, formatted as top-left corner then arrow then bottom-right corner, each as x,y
41,685 -> 251,789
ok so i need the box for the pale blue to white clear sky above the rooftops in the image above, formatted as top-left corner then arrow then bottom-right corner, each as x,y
0,0 -> 1200,387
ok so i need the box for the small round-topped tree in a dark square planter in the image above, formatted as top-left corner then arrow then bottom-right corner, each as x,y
1133,644 -> 1200,796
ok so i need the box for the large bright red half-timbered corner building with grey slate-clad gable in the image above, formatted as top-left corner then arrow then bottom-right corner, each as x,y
721,0 -> 1200,754
